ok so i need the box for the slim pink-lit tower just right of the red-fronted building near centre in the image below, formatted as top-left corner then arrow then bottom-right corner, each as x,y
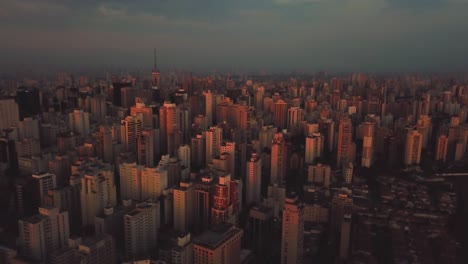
246,153 -> 262,204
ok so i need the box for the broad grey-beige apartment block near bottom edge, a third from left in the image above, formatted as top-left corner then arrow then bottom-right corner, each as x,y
124,201 -> 160,259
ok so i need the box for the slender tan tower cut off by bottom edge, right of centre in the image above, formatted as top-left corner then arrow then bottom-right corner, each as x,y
281,195 -> 304,264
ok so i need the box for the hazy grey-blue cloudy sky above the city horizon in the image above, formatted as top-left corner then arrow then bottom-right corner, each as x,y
0,0 -> 468,72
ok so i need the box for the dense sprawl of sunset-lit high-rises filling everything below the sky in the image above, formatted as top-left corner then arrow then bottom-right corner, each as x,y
0,67 -> 468,264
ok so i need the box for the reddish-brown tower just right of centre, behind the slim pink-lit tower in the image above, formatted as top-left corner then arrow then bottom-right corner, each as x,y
270,133 -> 288,184
